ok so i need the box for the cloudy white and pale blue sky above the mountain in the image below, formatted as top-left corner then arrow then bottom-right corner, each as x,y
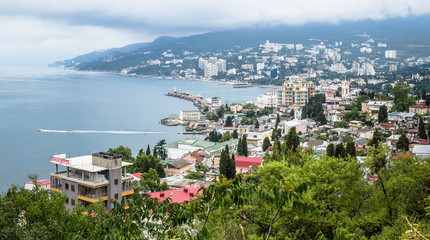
0,0 -> 430,66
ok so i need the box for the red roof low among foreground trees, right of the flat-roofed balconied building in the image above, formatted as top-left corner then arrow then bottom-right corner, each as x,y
147,186 -> 200,203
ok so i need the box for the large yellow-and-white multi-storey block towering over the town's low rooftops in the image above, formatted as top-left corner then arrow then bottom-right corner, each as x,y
278,80 -> 315,106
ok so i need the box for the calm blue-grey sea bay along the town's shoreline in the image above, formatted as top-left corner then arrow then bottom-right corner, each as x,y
0,65 -> 270,192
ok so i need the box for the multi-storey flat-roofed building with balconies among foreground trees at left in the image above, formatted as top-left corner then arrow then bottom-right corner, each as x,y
50,152 -> 134,210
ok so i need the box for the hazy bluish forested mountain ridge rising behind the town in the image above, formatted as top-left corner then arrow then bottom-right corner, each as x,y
55,15 -> 430,71
